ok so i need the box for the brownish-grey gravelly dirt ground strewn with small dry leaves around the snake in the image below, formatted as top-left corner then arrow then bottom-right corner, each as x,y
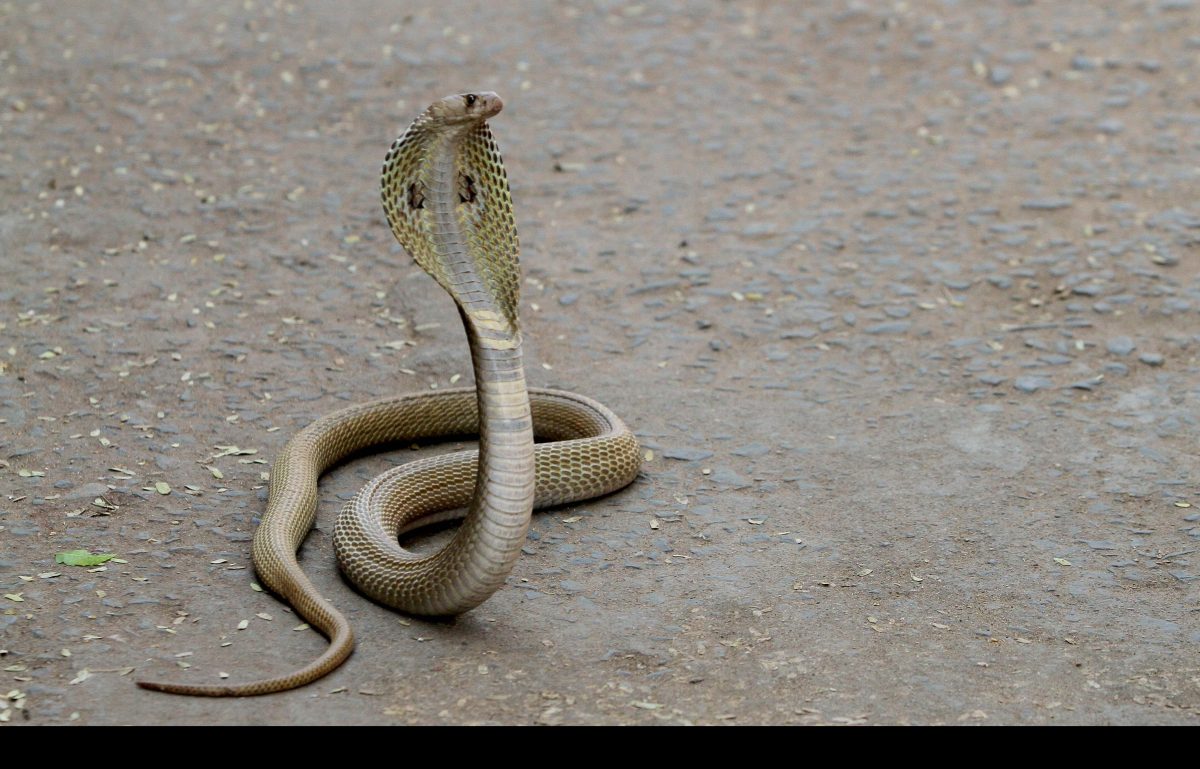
0,0 -> 1200,725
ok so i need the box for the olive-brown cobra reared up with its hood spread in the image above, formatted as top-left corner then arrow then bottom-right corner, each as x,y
138,92 -> 642,697
